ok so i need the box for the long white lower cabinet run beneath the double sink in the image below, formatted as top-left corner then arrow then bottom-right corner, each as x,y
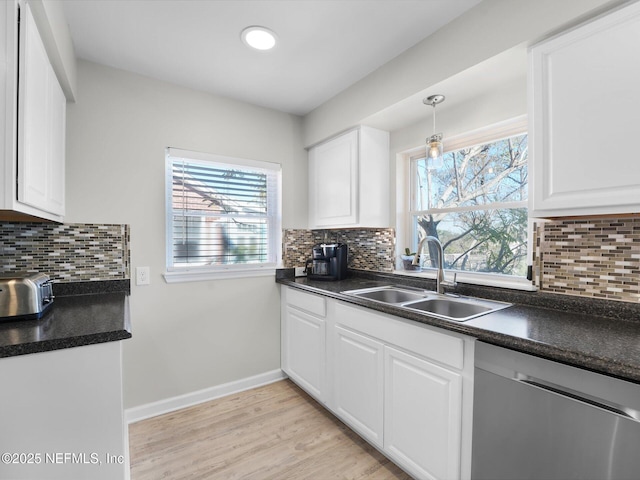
282,286 -> 474,480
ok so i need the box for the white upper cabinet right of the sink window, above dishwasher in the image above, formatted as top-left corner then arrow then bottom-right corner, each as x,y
529,3 -> 640,218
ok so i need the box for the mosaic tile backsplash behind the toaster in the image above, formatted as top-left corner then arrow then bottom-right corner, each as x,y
0,223 -> 130,283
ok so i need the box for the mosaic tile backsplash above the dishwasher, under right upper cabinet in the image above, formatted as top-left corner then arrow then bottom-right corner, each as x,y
534,218 -> 640,303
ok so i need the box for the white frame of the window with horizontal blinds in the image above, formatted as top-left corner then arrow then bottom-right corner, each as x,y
164,147 -> 282,283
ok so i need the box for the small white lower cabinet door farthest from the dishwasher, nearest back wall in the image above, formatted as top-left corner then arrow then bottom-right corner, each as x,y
283,306 -> 326,402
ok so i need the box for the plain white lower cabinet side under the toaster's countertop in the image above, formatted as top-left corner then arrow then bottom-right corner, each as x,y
0,342 -> 129,480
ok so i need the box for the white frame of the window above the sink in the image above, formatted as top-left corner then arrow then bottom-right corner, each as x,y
395,115 -> 536,291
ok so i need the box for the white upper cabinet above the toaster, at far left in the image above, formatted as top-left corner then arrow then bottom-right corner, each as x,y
0,2 -> 67,222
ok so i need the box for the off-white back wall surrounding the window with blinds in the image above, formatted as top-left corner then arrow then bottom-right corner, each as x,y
65,61 -> 307,408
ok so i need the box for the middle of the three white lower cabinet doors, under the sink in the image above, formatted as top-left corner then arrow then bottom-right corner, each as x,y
333,326 -> 384,448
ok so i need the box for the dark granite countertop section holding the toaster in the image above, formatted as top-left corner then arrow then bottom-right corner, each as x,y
0,280 -> 131,357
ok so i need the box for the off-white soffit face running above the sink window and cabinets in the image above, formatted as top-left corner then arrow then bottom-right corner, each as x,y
303,0 -> 620,146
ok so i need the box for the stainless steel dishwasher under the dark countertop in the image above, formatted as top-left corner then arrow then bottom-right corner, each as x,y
471,342 -> 640,480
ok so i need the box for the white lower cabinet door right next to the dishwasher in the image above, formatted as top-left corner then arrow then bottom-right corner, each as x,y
384,347 -> 462,479
